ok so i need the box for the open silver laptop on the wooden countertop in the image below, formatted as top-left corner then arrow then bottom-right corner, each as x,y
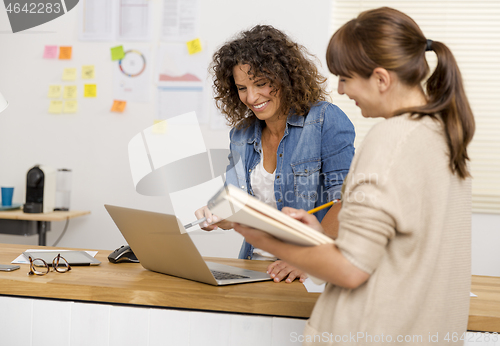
104,204 -> 271,286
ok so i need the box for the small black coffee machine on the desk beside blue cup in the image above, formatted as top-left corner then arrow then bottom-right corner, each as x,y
23,165 -> 56,213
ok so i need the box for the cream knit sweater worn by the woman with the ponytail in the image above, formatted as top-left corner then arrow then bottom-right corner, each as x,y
303,115 -> 471,345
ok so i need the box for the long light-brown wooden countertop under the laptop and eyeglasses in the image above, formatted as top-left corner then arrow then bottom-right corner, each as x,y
0,244 -> 500,332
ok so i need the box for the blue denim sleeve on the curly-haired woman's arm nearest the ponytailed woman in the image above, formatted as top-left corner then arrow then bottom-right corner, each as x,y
321,104 -> 355,201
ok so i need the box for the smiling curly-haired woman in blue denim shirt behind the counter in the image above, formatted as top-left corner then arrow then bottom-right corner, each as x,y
195,25 -> 355,282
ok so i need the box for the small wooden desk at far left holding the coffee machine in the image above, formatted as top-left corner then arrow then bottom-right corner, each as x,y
0,209 -> 90,246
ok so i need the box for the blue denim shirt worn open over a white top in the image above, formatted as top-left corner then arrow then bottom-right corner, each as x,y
226,101 -> 355,259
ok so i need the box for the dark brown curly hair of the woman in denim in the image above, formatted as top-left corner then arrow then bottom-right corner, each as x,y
210,25 -> 327,128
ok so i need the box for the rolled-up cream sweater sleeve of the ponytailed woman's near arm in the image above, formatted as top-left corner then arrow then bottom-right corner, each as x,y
335,120 -> 410,274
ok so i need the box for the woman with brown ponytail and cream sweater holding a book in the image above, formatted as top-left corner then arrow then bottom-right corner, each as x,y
235,7 -> 475,345
